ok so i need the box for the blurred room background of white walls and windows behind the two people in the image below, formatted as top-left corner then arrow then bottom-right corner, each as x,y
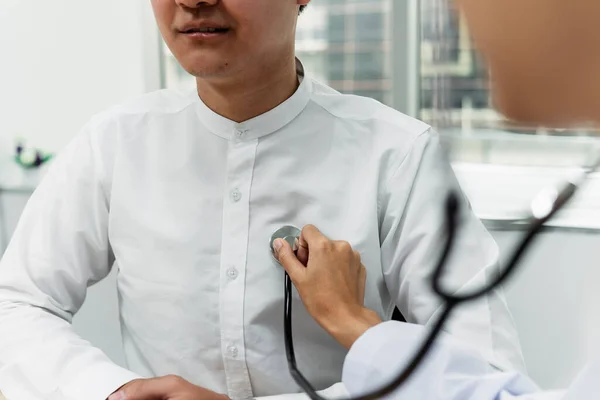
0,0 -> 600,394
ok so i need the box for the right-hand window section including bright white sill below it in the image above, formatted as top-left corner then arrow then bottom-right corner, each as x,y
420,0 -> 600,229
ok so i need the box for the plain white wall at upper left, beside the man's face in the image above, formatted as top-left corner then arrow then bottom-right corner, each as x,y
0,0 -> 156,156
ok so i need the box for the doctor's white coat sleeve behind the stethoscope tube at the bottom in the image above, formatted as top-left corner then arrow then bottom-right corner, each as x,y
342,321 -> 564,400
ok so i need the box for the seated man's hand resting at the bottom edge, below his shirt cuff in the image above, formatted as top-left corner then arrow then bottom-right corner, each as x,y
108,375 -> 229,400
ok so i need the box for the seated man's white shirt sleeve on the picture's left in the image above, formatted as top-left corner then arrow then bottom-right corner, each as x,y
0,123 -> 138,400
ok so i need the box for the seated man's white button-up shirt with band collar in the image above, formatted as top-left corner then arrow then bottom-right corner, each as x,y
0,61 -> 522,400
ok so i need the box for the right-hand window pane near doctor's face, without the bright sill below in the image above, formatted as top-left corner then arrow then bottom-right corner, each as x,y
420,0 -> 598,167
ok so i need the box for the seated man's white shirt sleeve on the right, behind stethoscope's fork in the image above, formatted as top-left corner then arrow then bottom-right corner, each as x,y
380,131 -> 525,371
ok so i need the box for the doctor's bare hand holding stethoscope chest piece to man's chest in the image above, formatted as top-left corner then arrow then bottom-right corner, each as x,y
274,225 -> 381,349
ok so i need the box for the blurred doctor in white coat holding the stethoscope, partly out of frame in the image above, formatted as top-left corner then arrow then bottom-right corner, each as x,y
275,0 -> 600,400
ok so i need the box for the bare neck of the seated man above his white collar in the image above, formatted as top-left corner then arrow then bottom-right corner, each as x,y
197,57 -> 298,122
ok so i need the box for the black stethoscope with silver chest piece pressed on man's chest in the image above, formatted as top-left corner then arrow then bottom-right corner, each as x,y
269,158 -> 600,400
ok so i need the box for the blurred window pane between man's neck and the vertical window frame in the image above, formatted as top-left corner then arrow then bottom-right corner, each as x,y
296,0 -> 392,104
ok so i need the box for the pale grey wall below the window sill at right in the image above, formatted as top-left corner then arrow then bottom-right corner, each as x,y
493,230 -> 600,389
